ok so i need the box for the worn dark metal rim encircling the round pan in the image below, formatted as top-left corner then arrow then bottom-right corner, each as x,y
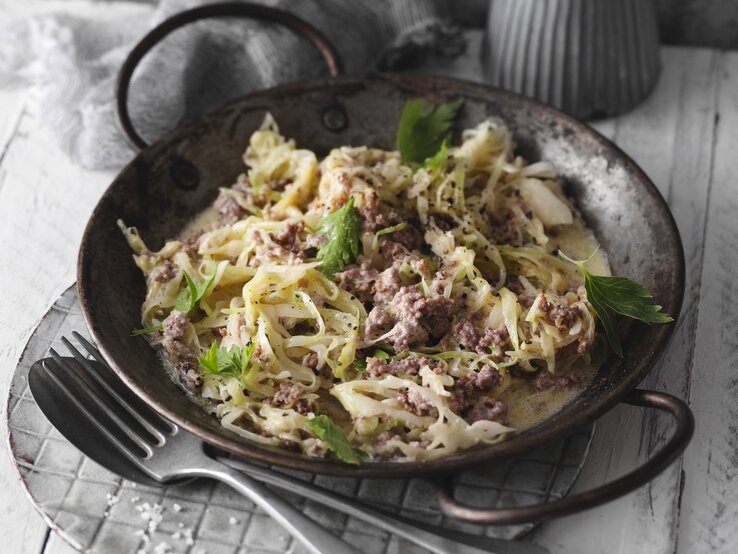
77,73 -> 686,477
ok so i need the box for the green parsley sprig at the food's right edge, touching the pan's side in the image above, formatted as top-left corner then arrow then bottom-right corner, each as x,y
559,251 -> 674,358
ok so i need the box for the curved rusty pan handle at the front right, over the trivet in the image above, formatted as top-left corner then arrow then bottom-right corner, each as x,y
436,389 -> 694,525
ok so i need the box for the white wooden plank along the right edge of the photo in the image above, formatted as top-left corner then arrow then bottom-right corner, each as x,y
678,48 -> 738,553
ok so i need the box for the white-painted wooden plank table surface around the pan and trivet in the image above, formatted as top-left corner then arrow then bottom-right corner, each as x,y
0,0 -> 738,554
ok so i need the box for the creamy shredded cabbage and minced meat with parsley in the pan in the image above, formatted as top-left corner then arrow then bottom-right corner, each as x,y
120,100 -> 670,464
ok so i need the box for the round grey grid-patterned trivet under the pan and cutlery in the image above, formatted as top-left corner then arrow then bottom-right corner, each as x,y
7,288 -> 594,554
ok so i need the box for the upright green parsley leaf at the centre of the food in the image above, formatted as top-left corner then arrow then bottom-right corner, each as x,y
317,197 -> 360,277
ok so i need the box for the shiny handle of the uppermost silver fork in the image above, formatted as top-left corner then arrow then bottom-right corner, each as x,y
191,460 -> 362,554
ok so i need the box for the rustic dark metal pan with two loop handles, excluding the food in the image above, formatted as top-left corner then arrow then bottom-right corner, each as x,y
77,4 -> 694,523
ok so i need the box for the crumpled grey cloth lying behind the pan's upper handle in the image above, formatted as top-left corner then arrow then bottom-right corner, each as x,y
0,0 -> 463,168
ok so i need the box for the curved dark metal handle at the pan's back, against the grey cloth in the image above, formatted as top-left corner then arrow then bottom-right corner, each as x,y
115,2 -> 343,151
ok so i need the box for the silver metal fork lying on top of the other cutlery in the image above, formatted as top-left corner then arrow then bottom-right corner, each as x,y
44,334 -> 360,554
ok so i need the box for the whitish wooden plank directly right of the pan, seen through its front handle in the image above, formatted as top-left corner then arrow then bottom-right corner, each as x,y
536,49 -> 717,554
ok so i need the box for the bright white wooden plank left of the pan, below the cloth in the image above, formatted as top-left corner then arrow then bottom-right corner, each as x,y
0,100 -> 113,554
